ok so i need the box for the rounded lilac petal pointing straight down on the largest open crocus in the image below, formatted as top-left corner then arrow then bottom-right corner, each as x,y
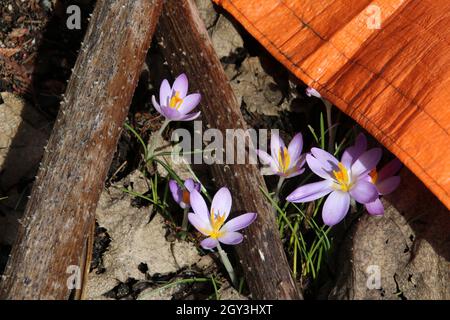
322,191 -> 350,227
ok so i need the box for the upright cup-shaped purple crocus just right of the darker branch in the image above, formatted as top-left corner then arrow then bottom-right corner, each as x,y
256,132 -> 305,178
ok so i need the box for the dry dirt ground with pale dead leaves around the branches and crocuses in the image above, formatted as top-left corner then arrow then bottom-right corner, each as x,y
0,0 -> 450,299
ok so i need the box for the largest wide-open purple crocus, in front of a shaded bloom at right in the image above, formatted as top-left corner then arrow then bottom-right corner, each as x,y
286,148 -> 381,226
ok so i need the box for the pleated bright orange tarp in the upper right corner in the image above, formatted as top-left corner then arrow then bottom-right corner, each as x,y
215,0 -> 450,208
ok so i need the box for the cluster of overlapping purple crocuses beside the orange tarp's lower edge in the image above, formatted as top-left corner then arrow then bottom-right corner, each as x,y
286,134 -> 400,226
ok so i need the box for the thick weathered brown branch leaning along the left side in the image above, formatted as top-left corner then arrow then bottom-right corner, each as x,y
0,0 -> 162,299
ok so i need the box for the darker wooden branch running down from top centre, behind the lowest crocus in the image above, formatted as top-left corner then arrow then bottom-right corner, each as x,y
156,0 -> 300,299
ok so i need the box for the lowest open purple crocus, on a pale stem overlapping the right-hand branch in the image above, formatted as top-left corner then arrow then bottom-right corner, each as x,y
188,187 -> 257,249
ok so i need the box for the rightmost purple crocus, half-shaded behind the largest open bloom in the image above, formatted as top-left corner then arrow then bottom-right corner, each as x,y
365,159 -> 402,215
